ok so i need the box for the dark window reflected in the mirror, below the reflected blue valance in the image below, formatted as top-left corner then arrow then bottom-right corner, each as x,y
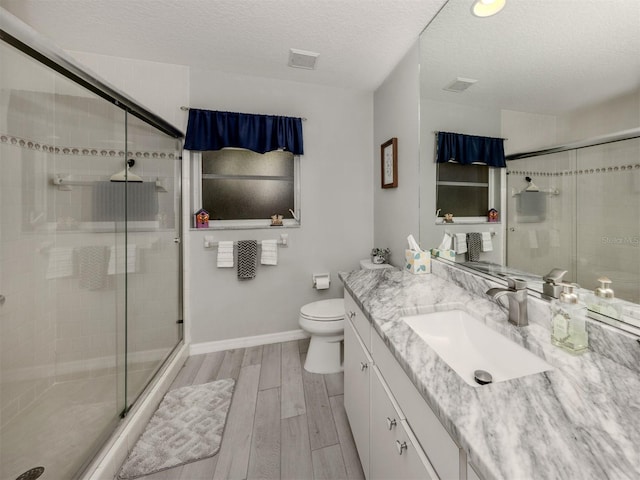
436,162 -> 500,222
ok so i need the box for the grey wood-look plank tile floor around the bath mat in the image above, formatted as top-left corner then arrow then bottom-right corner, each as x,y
132,340 -> 364,480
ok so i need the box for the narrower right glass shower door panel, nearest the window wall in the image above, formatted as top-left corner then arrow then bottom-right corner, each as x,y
121,115 -> 182,407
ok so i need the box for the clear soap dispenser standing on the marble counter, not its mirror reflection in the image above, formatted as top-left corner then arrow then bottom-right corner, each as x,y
551,283 -> 589,354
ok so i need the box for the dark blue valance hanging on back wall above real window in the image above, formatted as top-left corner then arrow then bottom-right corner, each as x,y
184,108 -> 303,155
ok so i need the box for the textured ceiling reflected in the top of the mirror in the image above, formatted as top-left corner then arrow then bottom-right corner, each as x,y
421,0 -> 640,118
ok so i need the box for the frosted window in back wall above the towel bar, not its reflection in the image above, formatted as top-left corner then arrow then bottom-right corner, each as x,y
193,148 -> 299,228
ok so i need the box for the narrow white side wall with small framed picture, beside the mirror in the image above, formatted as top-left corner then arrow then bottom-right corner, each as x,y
371,41 -> 420,266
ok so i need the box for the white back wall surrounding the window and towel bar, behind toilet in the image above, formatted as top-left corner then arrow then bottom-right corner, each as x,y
185,70 -> 373,343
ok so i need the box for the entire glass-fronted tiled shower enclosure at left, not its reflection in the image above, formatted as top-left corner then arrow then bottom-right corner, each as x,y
0,10 -> 182,480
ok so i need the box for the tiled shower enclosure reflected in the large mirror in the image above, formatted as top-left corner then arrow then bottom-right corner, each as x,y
507,131 -> 640,303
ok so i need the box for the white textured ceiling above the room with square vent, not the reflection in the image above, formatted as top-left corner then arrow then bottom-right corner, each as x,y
0,0 -> 448,90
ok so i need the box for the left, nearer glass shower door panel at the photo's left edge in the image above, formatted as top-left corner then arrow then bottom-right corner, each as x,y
0,43 -> 126,479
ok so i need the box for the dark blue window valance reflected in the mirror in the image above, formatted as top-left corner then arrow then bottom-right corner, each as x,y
436,132 -> 507,168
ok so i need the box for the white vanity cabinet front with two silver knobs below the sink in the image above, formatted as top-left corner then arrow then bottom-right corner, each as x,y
369,367 -> 438,480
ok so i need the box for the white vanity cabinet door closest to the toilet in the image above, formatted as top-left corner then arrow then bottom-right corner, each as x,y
344,320 -> 373,478
